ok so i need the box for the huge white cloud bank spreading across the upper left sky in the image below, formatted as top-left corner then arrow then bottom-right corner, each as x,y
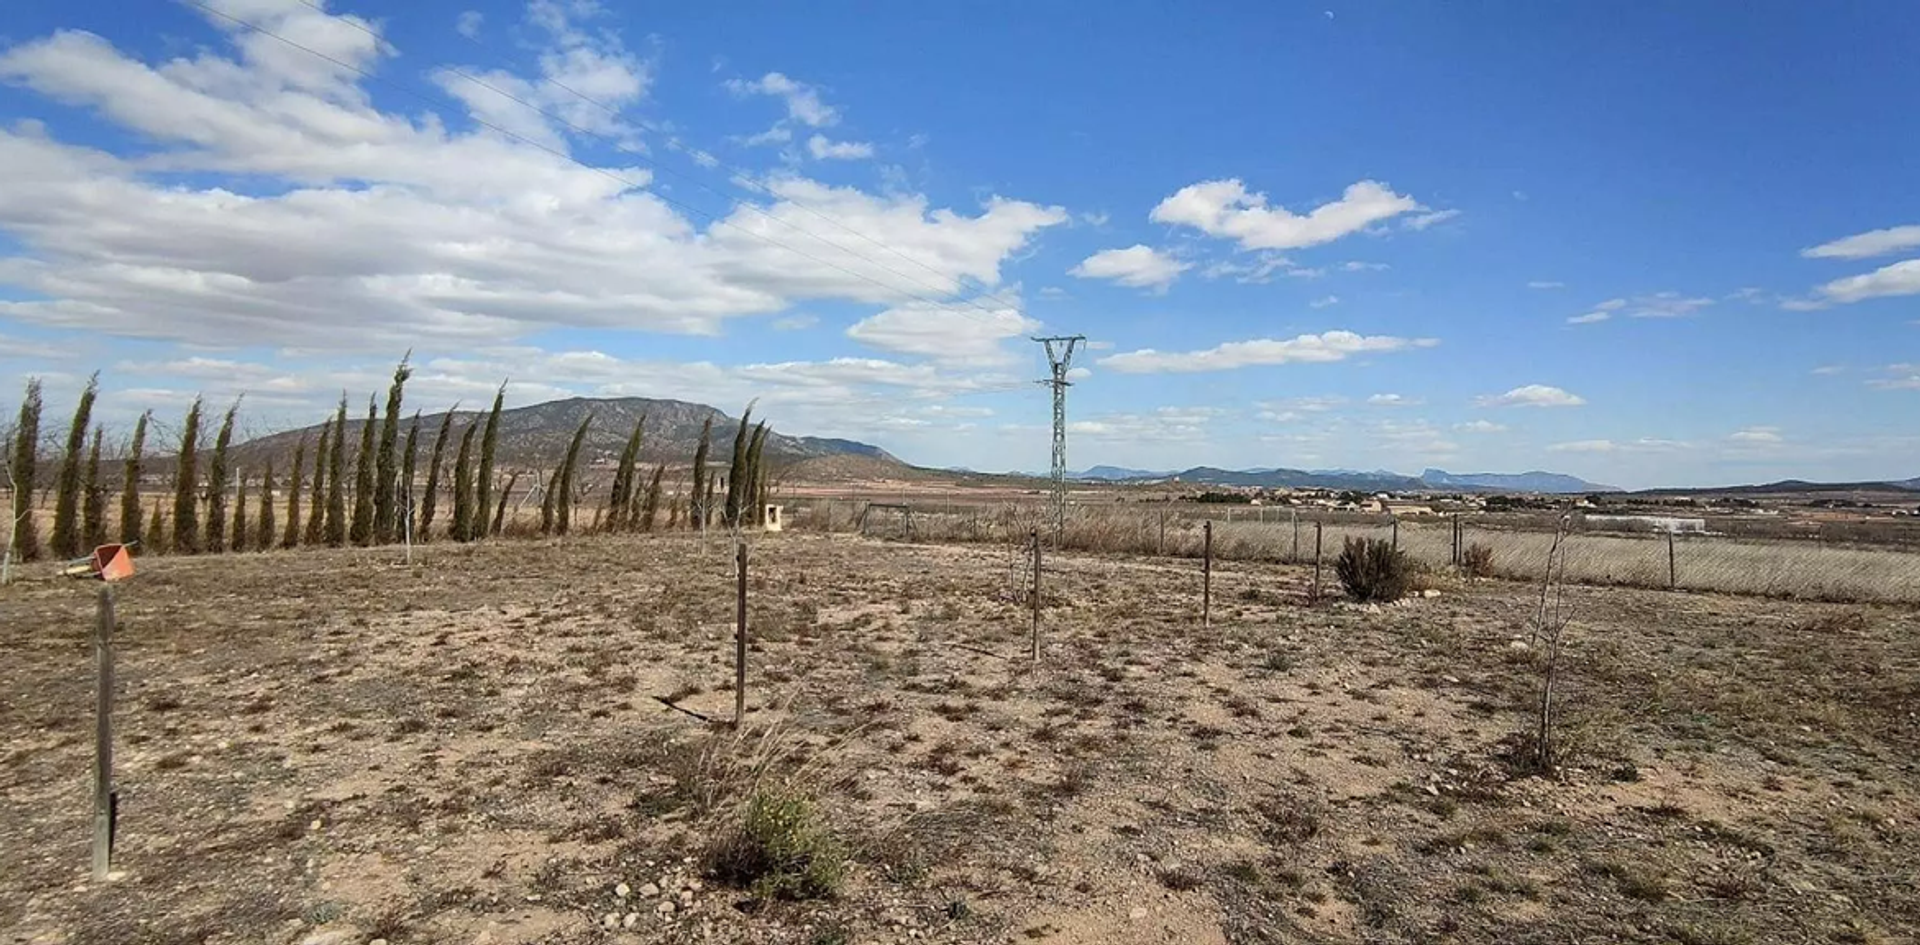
0,4 -> 1068,351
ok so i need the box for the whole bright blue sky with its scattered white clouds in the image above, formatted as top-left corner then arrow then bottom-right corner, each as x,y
0,0 -> 1920,486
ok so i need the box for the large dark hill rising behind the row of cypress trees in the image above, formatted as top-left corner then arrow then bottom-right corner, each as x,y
234,398 -> 912,474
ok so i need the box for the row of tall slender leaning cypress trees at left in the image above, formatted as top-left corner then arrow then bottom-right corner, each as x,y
6,357 -> 768,561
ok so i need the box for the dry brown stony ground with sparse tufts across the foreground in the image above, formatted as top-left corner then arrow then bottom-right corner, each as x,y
0,534 -> 1920,945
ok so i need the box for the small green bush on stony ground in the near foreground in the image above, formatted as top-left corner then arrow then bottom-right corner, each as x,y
707,789 -> 847,899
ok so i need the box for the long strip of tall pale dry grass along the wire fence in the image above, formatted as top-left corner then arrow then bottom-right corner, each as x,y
787,499 -> 1920,603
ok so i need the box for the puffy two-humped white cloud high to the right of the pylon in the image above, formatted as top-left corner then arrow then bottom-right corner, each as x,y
1148,179 -> 1423,250
